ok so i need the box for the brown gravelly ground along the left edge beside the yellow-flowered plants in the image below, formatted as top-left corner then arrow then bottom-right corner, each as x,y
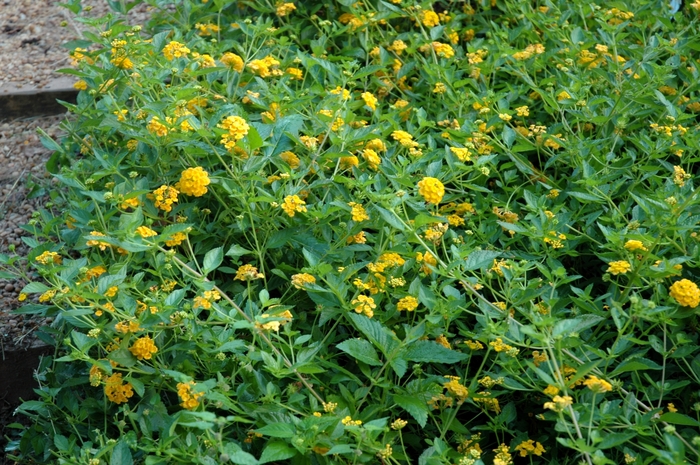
0,0 -> 149,464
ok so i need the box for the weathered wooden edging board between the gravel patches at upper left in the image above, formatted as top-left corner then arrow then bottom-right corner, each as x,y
0,77 -> 78,119
